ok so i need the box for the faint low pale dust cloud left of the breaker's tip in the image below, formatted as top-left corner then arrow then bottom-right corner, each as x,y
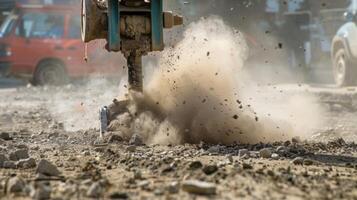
47,77 -> 119,132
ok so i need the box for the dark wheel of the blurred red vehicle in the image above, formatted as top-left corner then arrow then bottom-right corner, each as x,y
33,61 -> 69,86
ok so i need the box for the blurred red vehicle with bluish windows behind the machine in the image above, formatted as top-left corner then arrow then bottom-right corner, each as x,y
0,5 -> 125,85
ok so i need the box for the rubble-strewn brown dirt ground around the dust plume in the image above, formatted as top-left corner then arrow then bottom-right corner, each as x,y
0,83 -> 357,199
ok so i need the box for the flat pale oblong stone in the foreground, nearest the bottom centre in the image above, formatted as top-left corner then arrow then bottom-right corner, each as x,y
181,180 -> 216,195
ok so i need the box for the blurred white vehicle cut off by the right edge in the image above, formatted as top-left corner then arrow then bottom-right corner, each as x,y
331,4 -> 357,87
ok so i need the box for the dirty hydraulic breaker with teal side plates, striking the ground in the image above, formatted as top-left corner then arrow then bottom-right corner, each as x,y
82,0 -> 183,134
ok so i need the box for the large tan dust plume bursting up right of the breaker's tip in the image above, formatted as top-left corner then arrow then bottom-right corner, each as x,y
113,17 -> 321,144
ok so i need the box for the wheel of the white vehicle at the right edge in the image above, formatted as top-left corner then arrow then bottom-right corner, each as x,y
333,49 -> 357,87
